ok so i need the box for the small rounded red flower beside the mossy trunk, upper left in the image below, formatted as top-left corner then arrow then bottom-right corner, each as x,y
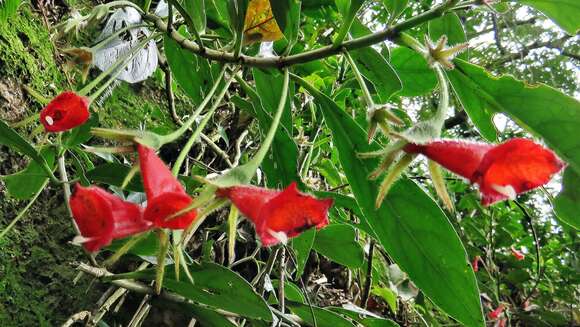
40,91 -> 90,132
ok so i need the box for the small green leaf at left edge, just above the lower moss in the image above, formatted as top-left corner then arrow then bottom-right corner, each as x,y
2,147 -> 56,200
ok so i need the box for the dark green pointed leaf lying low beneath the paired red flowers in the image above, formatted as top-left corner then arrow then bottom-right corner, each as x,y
112,262 -> 272,321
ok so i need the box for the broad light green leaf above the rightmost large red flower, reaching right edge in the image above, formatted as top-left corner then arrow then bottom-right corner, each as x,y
454,59 -> 580,173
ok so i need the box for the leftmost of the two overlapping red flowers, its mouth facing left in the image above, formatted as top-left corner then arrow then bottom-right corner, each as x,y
69,184 -> 151,252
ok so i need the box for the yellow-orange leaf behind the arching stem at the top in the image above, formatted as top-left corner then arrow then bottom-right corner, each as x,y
244,0 -> 284,44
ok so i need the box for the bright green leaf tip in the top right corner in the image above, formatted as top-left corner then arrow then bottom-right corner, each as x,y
518,0 -> 580,35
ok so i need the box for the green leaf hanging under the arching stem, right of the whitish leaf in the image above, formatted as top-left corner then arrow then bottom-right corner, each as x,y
163,31 -> 214,105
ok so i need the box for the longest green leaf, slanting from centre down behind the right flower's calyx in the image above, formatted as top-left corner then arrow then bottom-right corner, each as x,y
294,75 -> 484,326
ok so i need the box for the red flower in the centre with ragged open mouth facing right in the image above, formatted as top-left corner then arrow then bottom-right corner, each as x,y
217,183 -> 333,246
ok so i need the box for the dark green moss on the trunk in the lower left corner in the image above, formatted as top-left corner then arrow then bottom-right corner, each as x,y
0,191 -> 100,326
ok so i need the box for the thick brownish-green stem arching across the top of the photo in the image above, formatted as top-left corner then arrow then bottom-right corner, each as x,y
143,0 -> 458,68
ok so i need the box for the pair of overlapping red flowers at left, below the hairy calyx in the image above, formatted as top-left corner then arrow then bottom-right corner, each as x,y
70,145 -> 197,252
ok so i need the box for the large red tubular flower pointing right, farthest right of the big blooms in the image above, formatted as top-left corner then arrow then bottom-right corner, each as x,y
404,138 -> 564,205
